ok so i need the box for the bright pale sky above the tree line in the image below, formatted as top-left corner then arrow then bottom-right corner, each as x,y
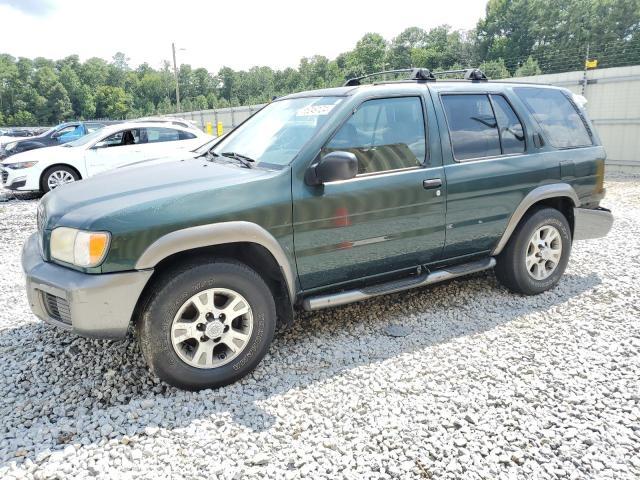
0,0 -> 486,72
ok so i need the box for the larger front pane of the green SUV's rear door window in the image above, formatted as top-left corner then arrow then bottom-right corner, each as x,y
442,94 -> 501,160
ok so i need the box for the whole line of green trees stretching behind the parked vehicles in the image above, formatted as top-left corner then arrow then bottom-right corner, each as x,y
0,0 -> 640,125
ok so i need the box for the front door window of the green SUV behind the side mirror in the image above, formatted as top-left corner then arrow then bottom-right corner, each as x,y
323,97 -> 426,174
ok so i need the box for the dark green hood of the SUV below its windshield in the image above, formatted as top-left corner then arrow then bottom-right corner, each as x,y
41,158 -> 280,231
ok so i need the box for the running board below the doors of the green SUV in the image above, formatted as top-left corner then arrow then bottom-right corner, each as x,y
302,257 -> 496,311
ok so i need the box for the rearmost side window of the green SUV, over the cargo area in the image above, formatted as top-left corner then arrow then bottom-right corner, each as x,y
514,87 -> 593,148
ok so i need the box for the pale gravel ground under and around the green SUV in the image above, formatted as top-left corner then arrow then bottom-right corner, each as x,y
0,177 -> 640,479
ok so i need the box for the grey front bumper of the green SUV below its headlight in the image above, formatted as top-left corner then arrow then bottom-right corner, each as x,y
22,233 -> 153,338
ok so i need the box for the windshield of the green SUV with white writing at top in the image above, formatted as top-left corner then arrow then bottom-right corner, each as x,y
213,97 -> 342,166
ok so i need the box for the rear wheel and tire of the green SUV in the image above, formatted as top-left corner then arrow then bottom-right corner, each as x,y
495,208 -> 571,295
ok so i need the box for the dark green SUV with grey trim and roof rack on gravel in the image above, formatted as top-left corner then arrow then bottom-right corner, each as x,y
22,69 -> 613,390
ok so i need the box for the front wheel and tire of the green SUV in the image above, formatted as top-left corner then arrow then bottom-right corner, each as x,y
136,260 -> 276,390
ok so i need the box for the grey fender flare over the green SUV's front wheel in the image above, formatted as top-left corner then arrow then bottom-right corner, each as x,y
135,221 -> 296,302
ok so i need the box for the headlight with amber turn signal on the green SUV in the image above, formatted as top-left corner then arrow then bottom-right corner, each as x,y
50,227 -> 111,267
